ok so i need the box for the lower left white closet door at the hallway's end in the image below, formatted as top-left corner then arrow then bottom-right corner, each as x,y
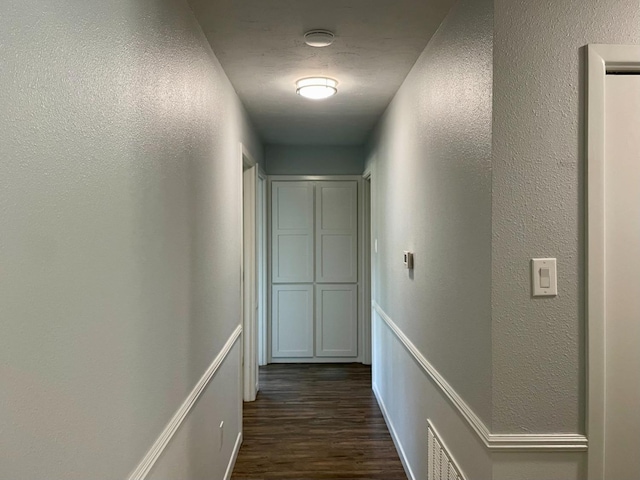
271,285 -> 313,358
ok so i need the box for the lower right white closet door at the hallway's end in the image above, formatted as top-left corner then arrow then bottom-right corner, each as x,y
316,284 -> 358,357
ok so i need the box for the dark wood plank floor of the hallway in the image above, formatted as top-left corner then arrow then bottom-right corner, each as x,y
232,364 -> 407,480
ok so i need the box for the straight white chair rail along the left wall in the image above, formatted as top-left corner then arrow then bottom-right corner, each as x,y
129,325 -> 242,480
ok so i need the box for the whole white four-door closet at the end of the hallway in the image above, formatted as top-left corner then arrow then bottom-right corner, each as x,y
267,175 -> 370,364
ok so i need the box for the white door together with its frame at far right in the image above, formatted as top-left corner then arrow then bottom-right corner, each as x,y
586,45 -> 640,480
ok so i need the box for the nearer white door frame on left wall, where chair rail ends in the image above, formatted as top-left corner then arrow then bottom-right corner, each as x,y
239,143 -> 259,402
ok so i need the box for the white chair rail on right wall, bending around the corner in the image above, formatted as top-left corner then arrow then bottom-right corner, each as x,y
371,301 -> 587,451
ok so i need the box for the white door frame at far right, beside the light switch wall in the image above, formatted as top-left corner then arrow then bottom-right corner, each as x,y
585,44 -> 640,480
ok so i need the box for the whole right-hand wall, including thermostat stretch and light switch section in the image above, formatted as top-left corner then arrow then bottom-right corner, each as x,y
367,0 -> 640,480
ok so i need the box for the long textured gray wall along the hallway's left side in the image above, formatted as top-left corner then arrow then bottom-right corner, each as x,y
0,0 -> 261,480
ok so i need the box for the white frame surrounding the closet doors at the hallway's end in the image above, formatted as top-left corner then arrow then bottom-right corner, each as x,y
266,175 -> 370,363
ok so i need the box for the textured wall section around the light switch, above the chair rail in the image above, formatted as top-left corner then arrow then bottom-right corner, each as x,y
492,0 -> 640,433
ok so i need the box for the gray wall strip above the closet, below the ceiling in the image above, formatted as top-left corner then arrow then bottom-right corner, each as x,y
265,145 -> 365,175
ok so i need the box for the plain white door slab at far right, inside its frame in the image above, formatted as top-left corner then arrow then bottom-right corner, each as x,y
605,75 -> 640,479
